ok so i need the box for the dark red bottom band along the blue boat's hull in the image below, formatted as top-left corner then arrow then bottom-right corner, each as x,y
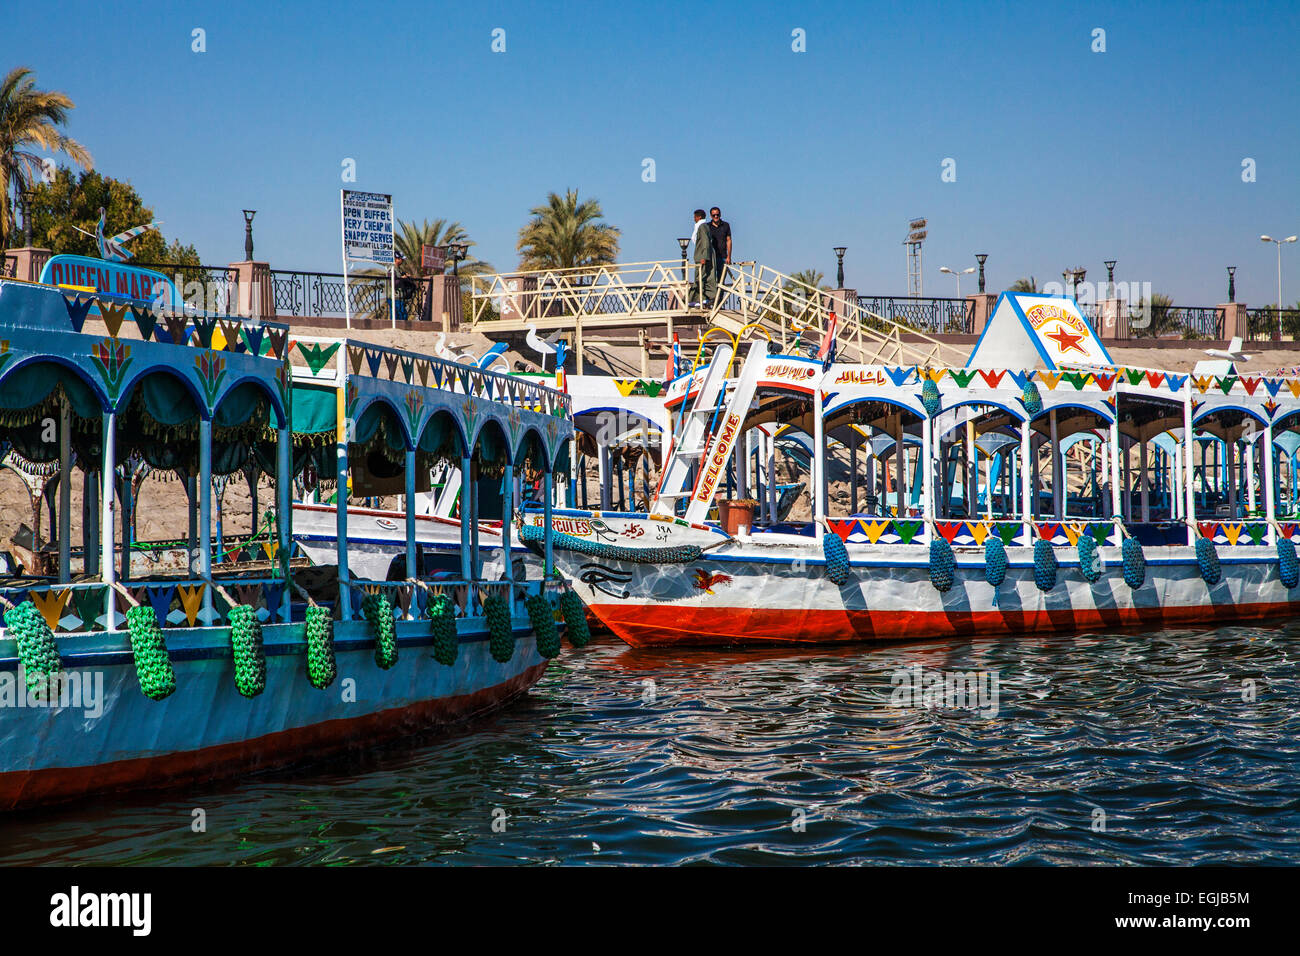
0,661 -> 547,810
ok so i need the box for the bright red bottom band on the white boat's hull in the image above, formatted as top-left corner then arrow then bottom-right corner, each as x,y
592,602 -> 1295,646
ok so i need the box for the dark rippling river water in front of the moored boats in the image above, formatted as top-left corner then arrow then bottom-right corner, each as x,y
0,624 -> 1300,865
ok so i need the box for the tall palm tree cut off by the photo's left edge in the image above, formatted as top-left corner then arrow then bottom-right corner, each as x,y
0,66 -> 92,245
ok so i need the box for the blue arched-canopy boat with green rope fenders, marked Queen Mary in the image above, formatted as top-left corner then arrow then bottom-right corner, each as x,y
0,267 -> 572,810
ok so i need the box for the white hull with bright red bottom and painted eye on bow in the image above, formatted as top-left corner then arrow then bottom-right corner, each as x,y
556,545 -> 1300,646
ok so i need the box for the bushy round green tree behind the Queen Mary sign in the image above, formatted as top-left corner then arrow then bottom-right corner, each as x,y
31,166 -> 199,265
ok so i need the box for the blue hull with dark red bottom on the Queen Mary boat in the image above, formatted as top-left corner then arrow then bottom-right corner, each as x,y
0,622 -> 546,810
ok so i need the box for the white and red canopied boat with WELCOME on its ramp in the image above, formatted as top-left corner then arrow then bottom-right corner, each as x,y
520,293 -> 1300,646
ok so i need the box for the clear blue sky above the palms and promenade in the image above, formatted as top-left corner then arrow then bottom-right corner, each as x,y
0,0 -> 1300,304
